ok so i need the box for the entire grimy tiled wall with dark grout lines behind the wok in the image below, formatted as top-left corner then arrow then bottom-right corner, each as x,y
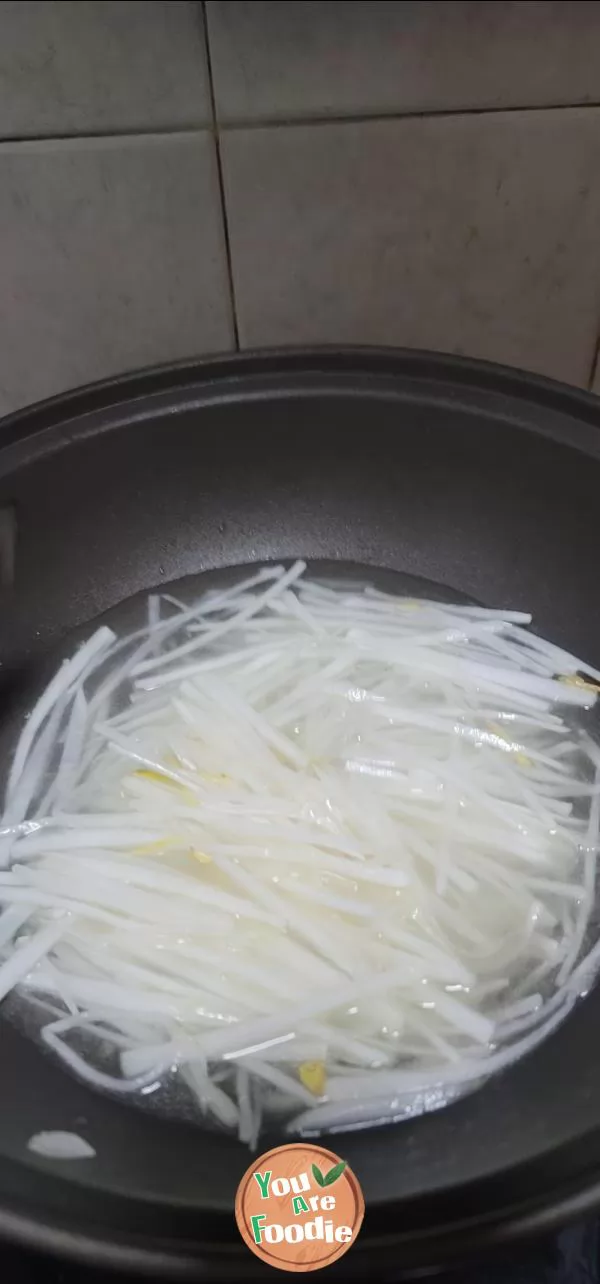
0,0 -> 600,411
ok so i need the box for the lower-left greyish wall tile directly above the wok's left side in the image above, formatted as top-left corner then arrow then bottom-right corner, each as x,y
0,134 -> 233,411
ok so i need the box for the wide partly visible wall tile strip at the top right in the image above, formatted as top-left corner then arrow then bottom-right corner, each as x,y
207,0 -> 600,123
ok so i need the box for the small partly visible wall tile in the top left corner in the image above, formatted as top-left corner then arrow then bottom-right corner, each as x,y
0,0 -> 211,137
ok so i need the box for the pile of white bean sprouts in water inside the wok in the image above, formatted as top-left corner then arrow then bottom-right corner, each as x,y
0,562 -> 600,1144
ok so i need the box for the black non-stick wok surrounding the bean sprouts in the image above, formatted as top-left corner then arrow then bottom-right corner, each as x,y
0,351 -> 600,1280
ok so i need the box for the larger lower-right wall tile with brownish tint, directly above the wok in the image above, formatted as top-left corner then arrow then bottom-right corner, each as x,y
222,108 -> 600,383
